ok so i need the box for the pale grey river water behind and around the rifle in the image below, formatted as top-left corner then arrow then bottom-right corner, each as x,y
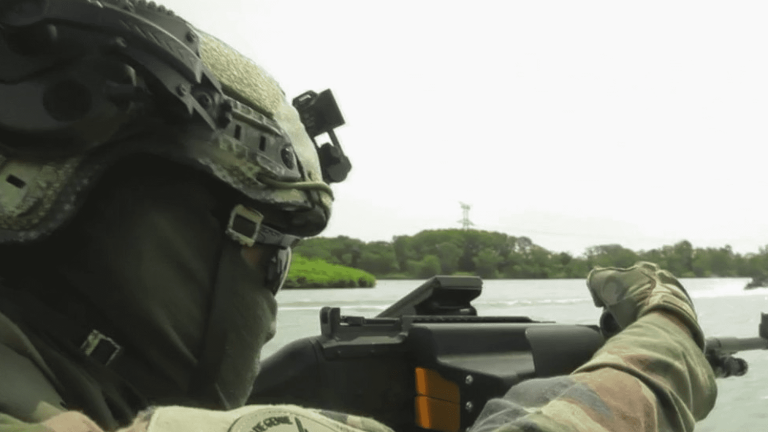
264,278 -> 768,432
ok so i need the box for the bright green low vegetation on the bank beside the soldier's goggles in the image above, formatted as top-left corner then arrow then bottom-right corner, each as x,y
283,254 -> 376,288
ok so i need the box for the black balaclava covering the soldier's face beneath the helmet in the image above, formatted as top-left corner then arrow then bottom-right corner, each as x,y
4,157 -> 279,409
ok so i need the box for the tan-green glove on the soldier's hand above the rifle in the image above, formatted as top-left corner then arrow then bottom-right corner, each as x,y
587,262 -> 704,350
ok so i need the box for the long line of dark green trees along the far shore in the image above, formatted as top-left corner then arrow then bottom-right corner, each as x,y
294,229 -> 768,279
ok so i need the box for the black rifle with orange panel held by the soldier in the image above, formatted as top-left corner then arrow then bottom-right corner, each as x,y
248,276 -> 768,432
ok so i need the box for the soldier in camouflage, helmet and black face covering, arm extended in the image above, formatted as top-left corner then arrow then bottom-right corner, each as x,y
0,0 -> 715,432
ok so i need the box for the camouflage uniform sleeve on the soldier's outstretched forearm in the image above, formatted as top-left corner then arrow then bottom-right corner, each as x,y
471,313 -> 717,432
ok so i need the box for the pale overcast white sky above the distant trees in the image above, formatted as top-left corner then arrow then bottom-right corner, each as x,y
156,0 -> 768,254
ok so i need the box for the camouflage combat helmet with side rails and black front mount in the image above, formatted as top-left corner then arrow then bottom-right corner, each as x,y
0,0 -> 351,247
